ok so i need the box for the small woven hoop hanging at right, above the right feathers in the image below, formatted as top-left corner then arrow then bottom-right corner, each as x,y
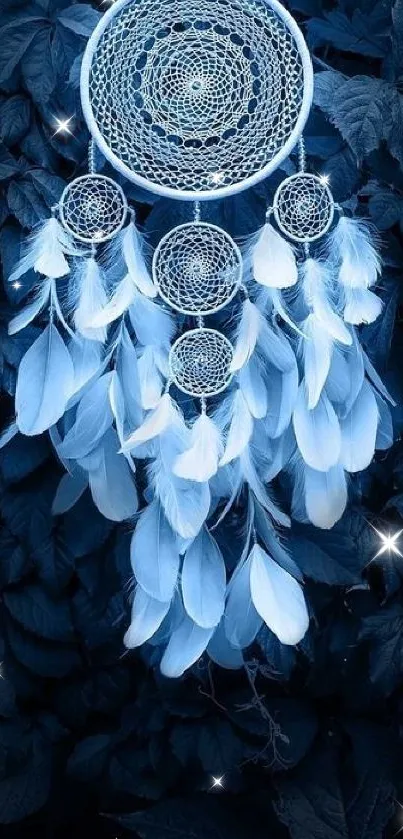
273,172 -> 334,242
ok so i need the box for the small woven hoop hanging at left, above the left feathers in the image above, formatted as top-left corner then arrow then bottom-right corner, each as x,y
59,175 -> 127,244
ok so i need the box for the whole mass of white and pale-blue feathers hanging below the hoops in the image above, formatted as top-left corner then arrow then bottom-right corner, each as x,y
6,189 -> 392,678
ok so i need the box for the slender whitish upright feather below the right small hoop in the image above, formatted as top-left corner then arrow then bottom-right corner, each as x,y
301,314 -> 332,408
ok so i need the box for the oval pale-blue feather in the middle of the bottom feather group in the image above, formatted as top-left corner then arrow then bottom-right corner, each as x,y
182,527 -> 226,629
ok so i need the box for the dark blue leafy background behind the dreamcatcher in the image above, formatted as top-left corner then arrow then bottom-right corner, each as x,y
0,0 -> 403,839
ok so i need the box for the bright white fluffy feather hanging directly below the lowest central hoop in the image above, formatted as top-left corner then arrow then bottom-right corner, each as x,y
173,412 -> 223,482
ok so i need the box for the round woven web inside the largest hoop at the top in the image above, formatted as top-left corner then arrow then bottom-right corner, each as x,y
85,0 -> 304,194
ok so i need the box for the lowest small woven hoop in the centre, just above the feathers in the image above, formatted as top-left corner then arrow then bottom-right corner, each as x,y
169,327 -> 233,396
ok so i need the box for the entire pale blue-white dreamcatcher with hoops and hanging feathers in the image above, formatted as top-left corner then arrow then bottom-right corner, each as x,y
6,0 -> 390,676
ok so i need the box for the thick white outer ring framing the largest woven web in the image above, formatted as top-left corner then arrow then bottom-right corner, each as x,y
80,0 -> 313,201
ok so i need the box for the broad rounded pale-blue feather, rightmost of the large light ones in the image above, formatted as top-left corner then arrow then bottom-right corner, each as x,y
340,380 -> 379,472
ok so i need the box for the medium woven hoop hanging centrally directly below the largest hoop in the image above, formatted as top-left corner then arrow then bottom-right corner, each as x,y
153,222 -> 242,315
